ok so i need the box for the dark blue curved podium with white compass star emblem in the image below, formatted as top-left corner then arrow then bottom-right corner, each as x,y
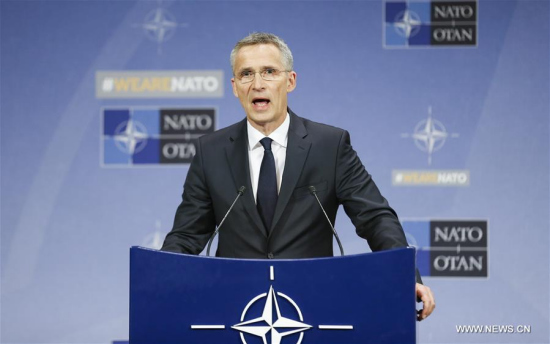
130,247 -> 416,344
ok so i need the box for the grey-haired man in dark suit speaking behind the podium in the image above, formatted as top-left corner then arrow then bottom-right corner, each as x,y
162,33 -> 435,319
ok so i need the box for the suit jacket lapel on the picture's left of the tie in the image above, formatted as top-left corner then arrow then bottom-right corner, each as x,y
226,119 -> 266,236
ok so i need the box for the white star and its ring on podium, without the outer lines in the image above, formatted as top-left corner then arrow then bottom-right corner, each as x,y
231,286 -> 312,344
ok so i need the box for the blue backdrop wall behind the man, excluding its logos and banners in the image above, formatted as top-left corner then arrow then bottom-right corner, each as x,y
0,0 -> 550,343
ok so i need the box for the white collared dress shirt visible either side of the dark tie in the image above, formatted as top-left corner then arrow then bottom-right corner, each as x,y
246,113 -> 290,200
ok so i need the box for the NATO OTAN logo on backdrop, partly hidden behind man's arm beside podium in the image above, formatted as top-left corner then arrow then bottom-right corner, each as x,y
402,220 -> 489,277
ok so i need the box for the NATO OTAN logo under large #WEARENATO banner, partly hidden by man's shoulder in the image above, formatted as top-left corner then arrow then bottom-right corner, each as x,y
101,107 -> 216,167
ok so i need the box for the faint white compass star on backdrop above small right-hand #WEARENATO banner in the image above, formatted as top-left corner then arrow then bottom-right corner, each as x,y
401,106 -> 458,165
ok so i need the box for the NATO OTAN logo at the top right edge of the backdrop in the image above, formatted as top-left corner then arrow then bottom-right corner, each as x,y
383,1 -> 477,48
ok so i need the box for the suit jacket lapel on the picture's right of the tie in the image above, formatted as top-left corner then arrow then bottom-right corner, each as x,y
269,109 -> 311,236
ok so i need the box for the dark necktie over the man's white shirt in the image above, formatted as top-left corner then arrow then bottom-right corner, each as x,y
256,137 -> 278,233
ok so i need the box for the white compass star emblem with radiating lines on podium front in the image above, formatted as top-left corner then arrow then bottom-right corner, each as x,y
191,266 -> 353,344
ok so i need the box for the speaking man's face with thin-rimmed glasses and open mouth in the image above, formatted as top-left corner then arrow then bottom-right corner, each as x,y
231,44 -> 296,131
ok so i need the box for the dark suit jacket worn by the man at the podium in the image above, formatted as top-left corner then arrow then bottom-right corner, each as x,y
162,110 -> 414,264
